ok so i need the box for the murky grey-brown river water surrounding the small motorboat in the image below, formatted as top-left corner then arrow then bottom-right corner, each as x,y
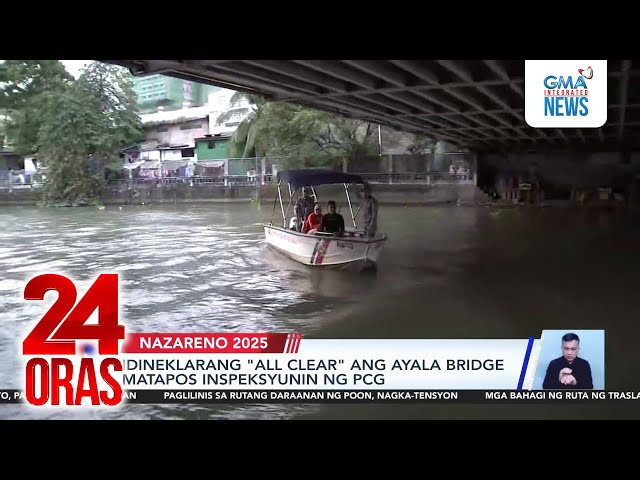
0,204 -> 640,419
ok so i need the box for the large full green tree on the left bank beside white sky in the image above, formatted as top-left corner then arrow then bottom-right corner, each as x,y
38,62 -> 144,206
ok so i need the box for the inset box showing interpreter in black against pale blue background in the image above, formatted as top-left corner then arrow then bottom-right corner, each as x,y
531,330 -> 605,390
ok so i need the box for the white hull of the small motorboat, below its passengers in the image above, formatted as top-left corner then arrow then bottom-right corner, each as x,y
264,225 -> 386,268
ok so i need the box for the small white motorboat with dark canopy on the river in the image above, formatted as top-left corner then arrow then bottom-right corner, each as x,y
264,169 -> 387,269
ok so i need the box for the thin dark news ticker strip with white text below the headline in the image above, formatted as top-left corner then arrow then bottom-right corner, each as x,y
0,390 -> 640,405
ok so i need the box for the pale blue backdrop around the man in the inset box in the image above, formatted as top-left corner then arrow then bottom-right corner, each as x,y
533,330 -> 604,390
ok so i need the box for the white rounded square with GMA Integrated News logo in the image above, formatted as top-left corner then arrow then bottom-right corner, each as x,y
524,60 -> 607,128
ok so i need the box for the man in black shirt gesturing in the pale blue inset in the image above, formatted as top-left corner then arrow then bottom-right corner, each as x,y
542,333 -> 593,390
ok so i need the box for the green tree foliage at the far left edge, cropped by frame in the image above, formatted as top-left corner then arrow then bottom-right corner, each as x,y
0,60 -> 73,155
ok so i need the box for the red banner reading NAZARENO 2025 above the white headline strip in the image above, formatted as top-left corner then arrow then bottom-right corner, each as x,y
122,333 -> 302,353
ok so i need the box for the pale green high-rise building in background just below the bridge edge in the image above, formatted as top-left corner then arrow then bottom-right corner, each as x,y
133,75 -> 221,114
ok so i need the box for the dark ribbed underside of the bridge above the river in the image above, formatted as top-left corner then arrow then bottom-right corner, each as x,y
104,60 -> 640,152
